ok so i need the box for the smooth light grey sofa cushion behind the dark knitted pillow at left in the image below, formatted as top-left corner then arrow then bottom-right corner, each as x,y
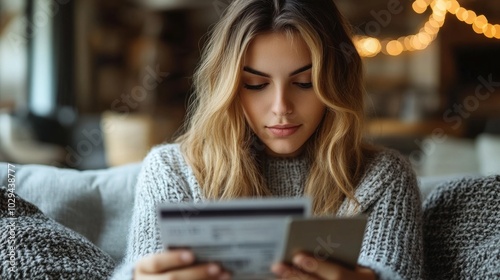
0,163 -> 141,262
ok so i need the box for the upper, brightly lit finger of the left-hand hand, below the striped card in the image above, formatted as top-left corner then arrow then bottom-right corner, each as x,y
136,250 -> 194,274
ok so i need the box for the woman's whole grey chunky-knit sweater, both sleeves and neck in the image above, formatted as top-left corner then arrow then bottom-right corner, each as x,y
113,144 -> 423,280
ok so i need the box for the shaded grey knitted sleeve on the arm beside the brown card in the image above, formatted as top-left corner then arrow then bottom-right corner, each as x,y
359,151 -> 423,279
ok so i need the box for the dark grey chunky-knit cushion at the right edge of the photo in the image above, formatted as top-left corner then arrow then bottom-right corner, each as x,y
424,175 -> 500,279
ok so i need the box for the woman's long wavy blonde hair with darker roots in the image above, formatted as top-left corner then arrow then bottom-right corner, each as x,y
177,0 -> 376,215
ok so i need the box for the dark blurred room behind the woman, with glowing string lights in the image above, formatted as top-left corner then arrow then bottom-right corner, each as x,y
0,0 -> 500,171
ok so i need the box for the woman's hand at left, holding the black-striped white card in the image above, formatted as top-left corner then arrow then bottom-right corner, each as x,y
134,250 -> 230,280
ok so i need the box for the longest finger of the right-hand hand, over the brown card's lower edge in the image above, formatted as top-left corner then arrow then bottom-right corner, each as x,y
292,253 -> 348,279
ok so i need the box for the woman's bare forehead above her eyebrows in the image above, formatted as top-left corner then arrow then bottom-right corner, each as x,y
244,32 -> 311,70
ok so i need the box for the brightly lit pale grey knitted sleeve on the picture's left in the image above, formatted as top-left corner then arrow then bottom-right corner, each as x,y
112,145 -> 195,280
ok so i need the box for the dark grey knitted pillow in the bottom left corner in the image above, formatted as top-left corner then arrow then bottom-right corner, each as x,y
0,187 -> 114,280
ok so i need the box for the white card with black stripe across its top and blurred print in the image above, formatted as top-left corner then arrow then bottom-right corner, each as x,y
158,198 -> 311,279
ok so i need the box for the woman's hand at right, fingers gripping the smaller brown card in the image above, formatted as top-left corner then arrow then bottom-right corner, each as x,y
271,253 -> 376,280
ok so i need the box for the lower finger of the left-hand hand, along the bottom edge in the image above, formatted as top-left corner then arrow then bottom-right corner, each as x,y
164,263 -> 230,280
